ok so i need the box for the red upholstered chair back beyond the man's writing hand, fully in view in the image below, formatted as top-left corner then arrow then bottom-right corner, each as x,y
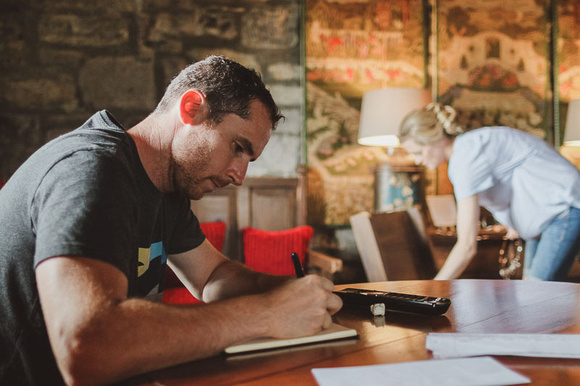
242,225 -> 314,275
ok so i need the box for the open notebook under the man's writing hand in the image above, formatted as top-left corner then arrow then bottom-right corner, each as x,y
225,323 -> 358,354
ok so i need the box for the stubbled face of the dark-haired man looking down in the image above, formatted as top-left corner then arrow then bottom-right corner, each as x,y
172,101 -> 272,200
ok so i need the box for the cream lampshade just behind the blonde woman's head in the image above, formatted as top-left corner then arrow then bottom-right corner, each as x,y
358,88 -> 431,147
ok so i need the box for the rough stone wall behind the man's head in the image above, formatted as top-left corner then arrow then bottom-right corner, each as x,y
0,0 -> 305,179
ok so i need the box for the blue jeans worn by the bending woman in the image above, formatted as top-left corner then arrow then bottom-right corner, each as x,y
524,208 -> 580,281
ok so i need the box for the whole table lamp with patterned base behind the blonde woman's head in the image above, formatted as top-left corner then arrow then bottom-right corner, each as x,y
358,88 -> 431,212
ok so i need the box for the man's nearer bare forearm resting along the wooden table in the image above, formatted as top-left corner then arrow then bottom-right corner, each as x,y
62,297 -> 276,383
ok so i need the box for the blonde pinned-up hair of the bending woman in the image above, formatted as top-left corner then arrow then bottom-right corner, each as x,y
399,103 -> 464,145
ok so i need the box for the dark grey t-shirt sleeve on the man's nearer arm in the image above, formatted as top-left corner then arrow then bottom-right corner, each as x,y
31,151 -> 138,275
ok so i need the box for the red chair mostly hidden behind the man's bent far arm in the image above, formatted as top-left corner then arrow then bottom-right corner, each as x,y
163,221 -> 226,304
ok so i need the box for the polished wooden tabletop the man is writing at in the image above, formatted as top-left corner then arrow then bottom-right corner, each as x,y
129,280 -> 580,386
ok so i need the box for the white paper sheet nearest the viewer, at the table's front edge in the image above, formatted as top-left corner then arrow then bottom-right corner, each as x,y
312,357 -> 530,386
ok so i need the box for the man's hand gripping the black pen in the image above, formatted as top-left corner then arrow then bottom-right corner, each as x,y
264,275 -> 342,338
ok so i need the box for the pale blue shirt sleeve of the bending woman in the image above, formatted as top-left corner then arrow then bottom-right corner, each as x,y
448,134 -> 493,201
